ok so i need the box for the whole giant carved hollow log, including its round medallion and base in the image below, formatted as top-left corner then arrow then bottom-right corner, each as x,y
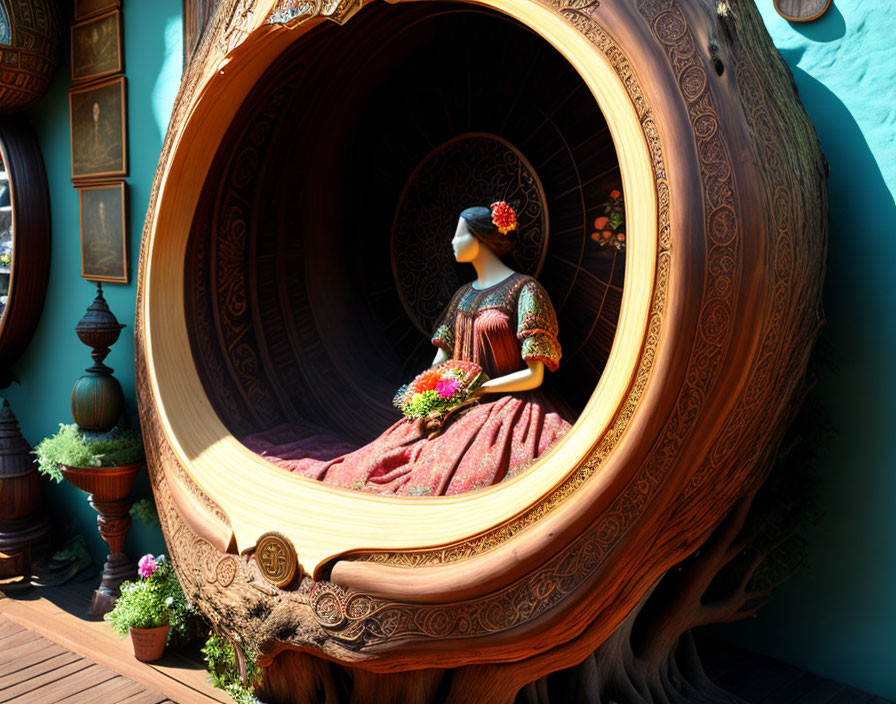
137,0 -> 826,701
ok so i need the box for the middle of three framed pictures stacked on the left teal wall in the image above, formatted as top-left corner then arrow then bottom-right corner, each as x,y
68,76 -> 128,181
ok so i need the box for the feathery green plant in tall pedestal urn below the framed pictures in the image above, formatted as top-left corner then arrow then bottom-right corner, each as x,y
34,423 -> 143,482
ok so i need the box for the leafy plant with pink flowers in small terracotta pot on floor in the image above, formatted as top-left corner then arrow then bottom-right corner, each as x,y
105,555 -> 199,642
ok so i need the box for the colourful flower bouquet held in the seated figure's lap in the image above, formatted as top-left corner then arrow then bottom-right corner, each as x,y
393,359 -> 488,421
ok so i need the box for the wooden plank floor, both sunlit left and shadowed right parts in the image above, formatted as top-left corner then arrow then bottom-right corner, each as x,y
0,579 -> 896,704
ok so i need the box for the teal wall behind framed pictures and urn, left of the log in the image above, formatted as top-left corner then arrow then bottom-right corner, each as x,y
3,0 -> 182,562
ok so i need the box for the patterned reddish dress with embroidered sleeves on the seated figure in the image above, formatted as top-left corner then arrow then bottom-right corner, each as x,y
245,273 -> 570,496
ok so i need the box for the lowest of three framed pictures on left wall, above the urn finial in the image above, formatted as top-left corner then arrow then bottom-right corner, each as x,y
78,181 -> 129,284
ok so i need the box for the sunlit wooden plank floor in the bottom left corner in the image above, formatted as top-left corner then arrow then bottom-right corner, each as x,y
0,578 -> 232,704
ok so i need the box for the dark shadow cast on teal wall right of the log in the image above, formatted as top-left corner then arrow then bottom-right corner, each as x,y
719,52 -> 896,699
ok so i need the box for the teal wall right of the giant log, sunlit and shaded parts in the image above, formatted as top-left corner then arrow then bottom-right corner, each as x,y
725,0 -> 896,700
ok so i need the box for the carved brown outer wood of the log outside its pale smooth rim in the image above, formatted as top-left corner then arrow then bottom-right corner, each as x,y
137,0 -> 826,676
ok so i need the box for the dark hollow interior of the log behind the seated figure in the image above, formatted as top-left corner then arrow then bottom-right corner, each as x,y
185,4 -> 626,490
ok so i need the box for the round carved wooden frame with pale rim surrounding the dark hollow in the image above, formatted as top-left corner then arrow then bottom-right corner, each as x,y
137,0 -> 826,676
